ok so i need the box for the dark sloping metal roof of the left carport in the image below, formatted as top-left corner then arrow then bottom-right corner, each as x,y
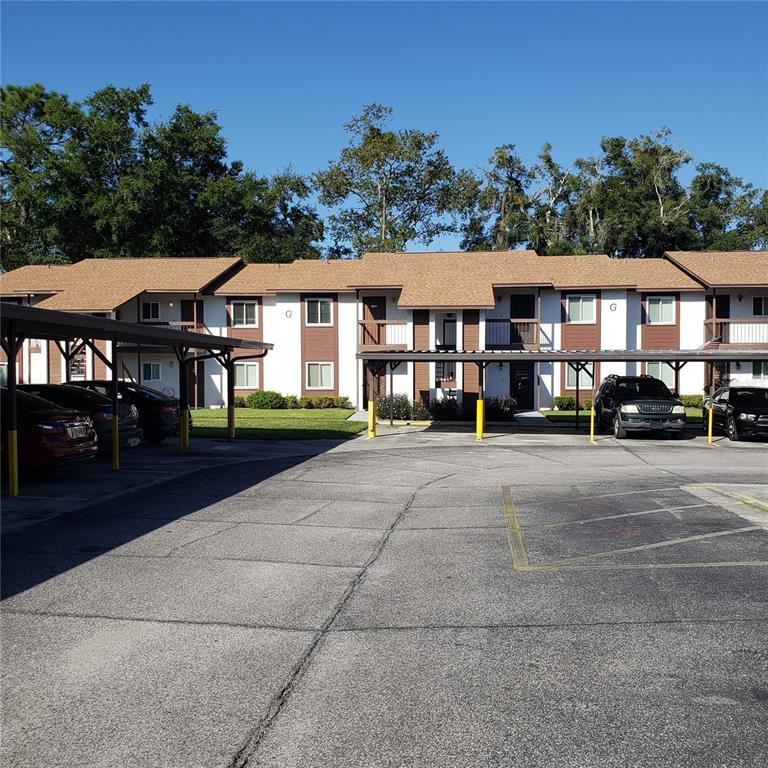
0,302 -> 273,351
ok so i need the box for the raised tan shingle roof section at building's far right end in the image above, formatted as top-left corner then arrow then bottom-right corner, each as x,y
664,251 -> 768,288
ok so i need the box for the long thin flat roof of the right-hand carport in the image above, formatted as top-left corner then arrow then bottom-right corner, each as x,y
357,347 -> 768,363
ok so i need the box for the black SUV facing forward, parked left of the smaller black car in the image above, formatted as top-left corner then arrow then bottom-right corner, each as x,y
595,375 -> 685,440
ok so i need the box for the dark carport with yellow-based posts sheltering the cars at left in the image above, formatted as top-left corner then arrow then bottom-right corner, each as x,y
0,302 -> 273,496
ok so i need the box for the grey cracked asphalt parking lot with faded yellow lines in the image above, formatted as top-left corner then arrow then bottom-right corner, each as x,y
2,429 -> 768,768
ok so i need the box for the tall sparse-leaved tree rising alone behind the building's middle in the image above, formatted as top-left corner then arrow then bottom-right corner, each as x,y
313,104 -> 477,255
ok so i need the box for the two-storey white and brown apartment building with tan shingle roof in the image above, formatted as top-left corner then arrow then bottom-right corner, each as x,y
0,251 -> 768,409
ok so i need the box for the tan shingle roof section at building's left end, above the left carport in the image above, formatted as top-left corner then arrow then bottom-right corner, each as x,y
0,257 -> 240,312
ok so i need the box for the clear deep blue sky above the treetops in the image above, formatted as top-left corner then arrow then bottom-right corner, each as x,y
2,2 -> 768,247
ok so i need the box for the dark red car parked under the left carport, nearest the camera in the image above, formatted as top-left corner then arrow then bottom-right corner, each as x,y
0,387 -> 98,472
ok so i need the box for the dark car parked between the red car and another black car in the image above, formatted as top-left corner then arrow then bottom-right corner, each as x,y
18,384 -> 141,451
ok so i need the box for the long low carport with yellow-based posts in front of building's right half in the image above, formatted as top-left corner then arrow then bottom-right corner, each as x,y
357,348 -> 768,441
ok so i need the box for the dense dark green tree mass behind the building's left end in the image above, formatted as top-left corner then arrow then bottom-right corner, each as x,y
0,84 -> 323,268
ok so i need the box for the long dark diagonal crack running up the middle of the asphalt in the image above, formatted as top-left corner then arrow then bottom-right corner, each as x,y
226,472 -> 456,768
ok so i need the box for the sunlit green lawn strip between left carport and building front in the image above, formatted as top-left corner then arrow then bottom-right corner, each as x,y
192,408 -> 367,440
